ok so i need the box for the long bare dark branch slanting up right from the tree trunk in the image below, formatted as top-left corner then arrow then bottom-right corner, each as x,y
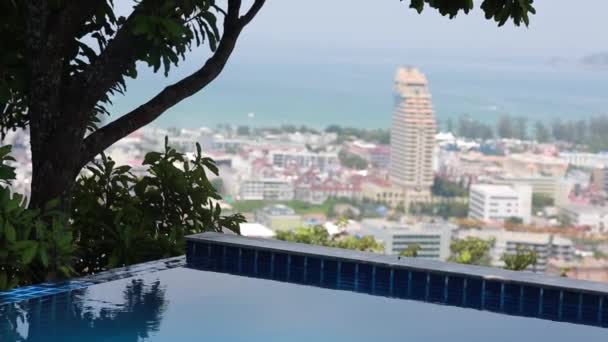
81,0 -> 265,165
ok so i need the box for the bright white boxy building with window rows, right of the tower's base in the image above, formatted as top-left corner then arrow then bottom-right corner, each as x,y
469,184 -> 532,224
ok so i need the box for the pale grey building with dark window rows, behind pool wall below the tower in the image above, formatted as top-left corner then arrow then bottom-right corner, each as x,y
348,219 -> 456,260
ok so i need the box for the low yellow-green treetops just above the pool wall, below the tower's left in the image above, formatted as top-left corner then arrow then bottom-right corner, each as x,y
275,226 -> 384,253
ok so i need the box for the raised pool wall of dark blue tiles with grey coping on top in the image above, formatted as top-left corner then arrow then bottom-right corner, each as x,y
186,233 -> 608,327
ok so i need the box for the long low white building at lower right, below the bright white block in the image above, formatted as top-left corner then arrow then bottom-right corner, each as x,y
457,229 -> 574,273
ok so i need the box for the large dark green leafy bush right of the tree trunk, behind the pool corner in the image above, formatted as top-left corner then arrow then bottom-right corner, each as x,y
72,139 -> 244,273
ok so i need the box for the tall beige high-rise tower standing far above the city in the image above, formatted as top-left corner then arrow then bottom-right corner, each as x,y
389,67 -> 437,209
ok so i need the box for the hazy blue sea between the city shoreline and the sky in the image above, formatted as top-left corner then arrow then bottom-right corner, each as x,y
111,56 -> 608,128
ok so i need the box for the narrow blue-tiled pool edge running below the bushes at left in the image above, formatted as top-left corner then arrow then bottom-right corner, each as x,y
0,256 -> 186,306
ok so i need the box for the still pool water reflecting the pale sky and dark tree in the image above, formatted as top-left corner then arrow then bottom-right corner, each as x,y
0,267 -> 608,342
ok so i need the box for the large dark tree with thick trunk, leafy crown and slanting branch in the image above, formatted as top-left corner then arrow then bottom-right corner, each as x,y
0,0 -> 265,210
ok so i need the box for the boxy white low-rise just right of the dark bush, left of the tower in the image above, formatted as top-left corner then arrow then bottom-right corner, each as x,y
239,178 -> 295,201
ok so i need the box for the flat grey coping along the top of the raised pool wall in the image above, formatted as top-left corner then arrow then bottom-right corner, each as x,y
186,232 -> 608,296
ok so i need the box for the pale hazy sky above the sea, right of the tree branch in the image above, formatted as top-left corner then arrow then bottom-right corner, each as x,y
232,0 -> 608,58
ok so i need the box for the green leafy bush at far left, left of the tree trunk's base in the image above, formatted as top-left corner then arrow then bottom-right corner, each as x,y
0,146 -> 74,290
